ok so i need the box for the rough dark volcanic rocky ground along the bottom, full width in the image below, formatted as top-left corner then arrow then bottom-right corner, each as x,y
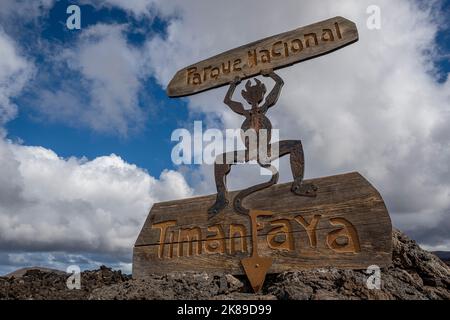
0,231 -> 450,300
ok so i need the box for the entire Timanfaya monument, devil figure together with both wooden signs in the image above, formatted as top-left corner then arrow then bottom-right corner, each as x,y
133,17 -> 392,292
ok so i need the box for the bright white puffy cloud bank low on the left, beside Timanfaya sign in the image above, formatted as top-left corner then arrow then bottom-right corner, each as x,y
0,141 -> 192,253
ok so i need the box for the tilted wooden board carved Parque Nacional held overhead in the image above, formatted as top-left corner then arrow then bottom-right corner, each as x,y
167,17 -> 358,97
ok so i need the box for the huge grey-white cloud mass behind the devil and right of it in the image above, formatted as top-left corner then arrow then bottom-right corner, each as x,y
143,1 -> 450,250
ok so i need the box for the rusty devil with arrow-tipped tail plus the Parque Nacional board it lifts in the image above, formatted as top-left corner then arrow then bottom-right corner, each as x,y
167,17 -> 358,290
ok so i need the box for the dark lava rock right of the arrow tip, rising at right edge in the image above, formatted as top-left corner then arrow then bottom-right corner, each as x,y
266,230 -> 450,300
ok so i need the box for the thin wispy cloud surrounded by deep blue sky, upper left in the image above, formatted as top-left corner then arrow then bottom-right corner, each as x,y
65,25 -> 144,134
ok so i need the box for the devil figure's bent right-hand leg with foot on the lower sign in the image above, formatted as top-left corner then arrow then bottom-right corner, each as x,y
279,140 -> 317,197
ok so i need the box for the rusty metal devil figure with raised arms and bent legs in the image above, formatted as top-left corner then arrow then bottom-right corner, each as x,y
208,70 -> 317,217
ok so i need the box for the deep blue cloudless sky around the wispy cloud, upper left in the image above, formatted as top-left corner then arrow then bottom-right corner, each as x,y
5,1 -> 189,176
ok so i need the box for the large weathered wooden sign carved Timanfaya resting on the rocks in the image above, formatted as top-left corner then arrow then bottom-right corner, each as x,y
133,173 -> 392,278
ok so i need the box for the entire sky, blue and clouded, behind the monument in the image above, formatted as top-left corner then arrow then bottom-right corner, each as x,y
0,0 -> 450,274
